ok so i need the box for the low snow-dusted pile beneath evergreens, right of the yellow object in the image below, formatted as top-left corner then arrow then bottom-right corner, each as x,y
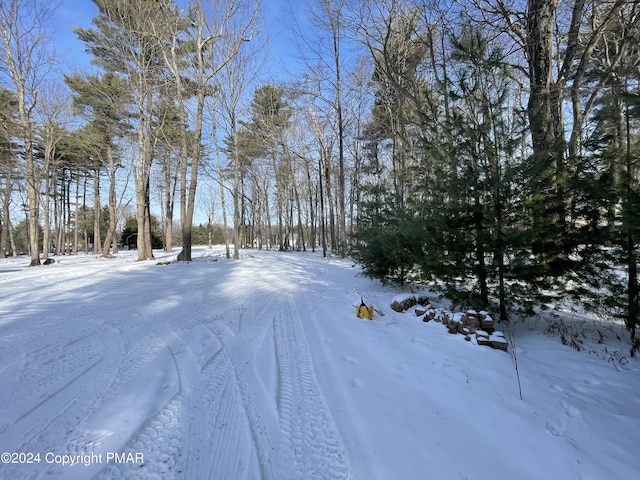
391,294 -> 508,352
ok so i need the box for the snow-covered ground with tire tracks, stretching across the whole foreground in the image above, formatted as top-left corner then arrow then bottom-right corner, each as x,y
0,248 -> 640,480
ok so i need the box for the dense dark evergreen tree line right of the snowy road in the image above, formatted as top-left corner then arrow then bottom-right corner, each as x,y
355,0 -> 640,356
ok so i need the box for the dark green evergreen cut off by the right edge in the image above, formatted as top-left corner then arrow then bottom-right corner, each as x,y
572,94 -> 640,356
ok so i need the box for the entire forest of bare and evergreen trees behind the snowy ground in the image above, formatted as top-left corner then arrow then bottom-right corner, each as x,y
0,0 -> 640,355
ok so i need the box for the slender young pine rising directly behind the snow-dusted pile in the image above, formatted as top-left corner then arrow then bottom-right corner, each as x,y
440,23 -> 523,320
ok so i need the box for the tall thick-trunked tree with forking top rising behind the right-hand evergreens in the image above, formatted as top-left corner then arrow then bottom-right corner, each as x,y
474,0 -> 628,277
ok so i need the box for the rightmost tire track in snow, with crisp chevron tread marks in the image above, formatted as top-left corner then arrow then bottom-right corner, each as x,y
273,298 -> 350,479
